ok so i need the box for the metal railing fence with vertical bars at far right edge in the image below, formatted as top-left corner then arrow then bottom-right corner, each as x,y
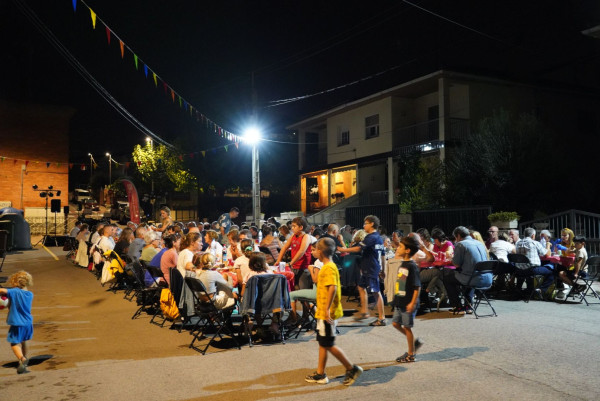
519,209 -> 600,256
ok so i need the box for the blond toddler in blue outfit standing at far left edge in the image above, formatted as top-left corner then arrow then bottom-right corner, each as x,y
0,271 -> 33,374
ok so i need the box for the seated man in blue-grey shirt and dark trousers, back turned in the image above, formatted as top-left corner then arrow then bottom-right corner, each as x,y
444,226 -> 492,315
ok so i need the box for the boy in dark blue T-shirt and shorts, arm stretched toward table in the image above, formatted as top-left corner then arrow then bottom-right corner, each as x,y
339,215 -> 386,326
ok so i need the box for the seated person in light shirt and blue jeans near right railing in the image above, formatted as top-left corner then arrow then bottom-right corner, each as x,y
515,227 -> 554,299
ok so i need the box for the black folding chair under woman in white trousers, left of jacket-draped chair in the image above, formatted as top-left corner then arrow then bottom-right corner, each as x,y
185,277 -> 241,355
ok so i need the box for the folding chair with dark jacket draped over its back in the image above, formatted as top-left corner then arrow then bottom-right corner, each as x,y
240,274 -> 290,347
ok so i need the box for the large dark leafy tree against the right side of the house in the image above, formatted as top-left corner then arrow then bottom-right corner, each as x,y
447,109 -> 552,210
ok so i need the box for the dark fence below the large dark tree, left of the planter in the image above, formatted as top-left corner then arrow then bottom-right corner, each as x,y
412,206 -> 492,236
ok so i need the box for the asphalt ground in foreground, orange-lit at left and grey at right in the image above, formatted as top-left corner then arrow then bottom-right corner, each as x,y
0,244 -> 600,400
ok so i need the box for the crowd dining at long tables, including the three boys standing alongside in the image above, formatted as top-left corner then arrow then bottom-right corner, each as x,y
61,207 -> 587,384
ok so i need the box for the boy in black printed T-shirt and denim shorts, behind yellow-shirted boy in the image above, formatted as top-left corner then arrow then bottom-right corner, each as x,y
392,237 -> 422,363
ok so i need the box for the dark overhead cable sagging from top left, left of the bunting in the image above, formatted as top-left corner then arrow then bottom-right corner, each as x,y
13,0 -> 176,150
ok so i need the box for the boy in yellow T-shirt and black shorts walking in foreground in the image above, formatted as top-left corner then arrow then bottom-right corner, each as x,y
305,238 -> 363,386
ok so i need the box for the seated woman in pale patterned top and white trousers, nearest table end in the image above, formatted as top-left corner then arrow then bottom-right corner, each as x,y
195,253 -> 237,309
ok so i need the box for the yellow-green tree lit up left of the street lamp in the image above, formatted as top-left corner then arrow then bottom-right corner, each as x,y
133,143 -> 197,192
